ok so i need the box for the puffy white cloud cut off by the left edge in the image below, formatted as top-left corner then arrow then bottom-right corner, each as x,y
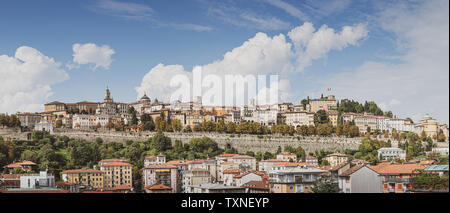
0,46 -> 69,113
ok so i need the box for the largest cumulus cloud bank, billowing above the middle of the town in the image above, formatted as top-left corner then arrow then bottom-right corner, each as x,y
136,23 -> 367,105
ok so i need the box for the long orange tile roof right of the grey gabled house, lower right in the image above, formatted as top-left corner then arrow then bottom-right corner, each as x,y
369,163 -> 426,174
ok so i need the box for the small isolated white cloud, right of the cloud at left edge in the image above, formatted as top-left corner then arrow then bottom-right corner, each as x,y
73,43 -> 115,69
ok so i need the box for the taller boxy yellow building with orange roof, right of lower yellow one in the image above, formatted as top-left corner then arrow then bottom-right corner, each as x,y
100,161 -> 133,188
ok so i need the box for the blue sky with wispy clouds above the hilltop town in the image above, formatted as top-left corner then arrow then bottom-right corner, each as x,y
0,0 -> 449,123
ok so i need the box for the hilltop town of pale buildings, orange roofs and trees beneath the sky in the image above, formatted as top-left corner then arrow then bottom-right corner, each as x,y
0,88 -> 449,193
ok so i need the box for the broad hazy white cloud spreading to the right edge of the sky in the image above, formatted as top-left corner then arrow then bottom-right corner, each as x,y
325,0 -> 449,123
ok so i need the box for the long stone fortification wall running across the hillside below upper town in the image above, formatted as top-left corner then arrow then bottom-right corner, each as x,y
53,130 -> 361,153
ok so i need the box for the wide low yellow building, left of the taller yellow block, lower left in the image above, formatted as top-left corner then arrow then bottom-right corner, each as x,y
62,169 -> 104,188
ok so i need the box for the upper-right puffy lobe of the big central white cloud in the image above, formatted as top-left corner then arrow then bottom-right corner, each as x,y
288,22 -> 368,71
